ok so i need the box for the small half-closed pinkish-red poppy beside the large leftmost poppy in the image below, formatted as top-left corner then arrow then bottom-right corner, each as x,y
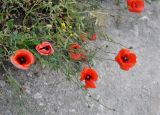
36,42 -> 54,56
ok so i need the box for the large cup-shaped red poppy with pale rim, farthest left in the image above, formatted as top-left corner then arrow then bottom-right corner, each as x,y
10,49 -> 35,70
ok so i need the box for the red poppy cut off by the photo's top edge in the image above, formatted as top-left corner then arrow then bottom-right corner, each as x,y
127,0 -> 144,13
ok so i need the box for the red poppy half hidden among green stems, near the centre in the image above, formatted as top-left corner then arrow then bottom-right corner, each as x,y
68,44 -> 86,60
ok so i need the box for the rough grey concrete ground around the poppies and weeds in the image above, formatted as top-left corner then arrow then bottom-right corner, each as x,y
0,0 -> 160,115
